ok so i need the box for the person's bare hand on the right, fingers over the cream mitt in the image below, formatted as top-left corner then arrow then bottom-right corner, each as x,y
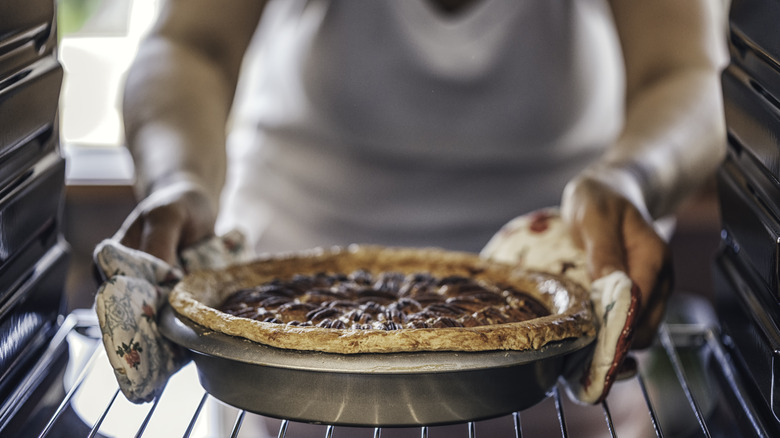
561,175 -> 672,348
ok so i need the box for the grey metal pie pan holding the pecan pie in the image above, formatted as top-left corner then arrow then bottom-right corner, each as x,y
158,306 -> 594,427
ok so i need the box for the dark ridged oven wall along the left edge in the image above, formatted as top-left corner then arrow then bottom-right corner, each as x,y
0,0 -> 70,436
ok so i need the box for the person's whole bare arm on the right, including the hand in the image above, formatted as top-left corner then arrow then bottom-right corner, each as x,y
562,0 -> 727,347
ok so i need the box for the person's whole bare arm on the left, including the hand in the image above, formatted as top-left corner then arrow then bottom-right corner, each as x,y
117,0 -> 265,263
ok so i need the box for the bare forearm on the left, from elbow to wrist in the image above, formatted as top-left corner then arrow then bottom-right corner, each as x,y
123,38 -> 234,203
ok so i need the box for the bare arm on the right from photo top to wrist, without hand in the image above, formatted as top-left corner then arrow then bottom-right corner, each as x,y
588,0 -> 728,218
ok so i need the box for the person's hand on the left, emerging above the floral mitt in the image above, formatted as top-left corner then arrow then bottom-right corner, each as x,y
114,181 -> 216,265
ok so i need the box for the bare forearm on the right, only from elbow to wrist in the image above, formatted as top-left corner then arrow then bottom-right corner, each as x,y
602,68 -> 726,218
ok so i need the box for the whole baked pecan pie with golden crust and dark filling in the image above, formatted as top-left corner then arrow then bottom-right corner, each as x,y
169,245 -> 596,354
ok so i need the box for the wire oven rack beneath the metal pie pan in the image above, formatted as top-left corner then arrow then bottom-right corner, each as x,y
18,310 -> 777,438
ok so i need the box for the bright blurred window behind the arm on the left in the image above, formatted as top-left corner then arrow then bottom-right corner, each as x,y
57,0 -> 158,180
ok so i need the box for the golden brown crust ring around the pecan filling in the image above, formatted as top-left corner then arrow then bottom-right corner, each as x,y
169,245 -> 596,354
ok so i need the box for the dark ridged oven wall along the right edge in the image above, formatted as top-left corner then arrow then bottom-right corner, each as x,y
715,0 -> 780,428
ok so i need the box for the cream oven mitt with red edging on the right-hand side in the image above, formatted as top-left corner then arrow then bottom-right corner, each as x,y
480,208 -> 639,404
